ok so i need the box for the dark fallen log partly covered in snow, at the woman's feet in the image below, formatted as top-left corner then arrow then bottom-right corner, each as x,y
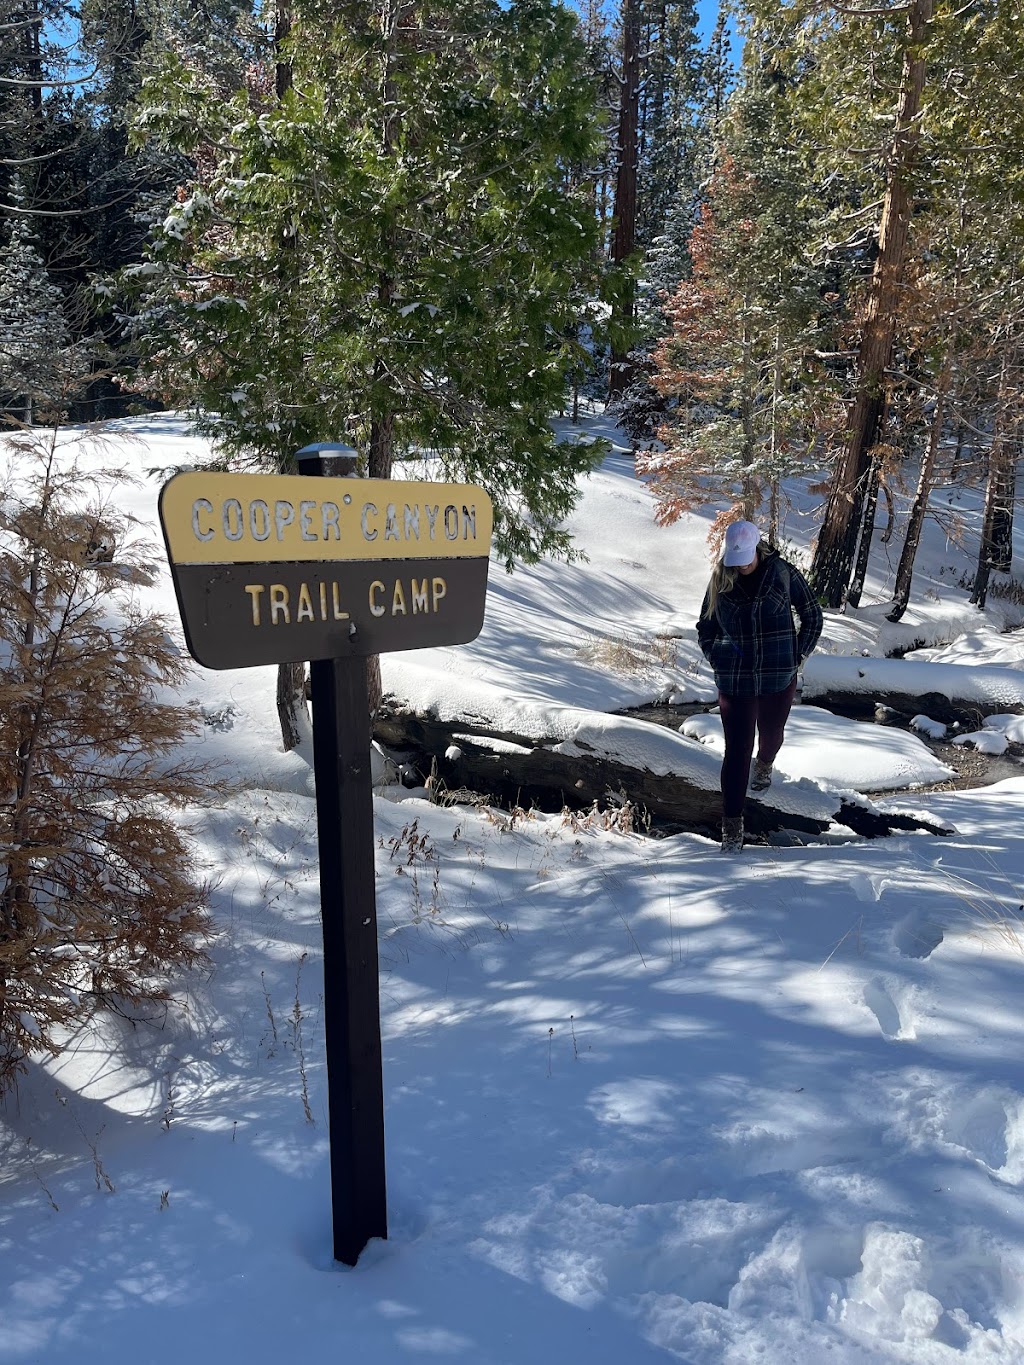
374,698 -> 949,838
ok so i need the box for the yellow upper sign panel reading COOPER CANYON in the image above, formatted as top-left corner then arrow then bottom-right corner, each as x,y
160,472 -> 493,564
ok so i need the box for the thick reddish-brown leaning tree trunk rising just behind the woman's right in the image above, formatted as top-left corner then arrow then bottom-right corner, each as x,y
811,0 -> 934,607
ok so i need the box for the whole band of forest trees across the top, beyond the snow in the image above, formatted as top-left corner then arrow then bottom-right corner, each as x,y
0,0 -> 1024,617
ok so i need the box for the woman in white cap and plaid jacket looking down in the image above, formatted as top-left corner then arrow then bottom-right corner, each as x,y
696,521 -> 822,853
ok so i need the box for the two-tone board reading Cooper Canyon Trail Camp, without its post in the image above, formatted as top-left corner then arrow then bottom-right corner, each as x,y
160,472 -> 492,669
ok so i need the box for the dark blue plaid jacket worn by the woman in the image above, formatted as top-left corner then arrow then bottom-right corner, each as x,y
696,550 -> 822,696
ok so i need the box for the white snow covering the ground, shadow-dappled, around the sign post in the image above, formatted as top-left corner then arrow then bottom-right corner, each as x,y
0,418 -> 1024,1365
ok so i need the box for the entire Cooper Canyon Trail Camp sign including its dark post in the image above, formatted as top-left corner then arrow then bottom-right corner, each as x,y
160,445 -> 493,1265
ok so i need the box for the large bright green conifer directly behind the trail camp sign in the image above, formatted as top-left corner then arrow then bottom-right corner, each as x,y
125,0 -> 614,565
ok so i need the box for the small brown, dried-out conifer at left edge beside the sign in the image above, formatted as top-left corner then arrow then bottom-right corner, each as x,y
0,427 -> 208,1091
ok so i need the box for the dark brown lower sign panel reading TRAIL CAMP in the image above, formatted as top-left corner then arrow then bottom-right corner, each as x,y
172,558 -> 487,669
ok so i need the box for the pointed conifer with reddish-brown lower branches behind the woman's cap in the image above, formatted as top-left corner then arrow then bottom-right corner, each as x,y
638,34 -> 838,534
